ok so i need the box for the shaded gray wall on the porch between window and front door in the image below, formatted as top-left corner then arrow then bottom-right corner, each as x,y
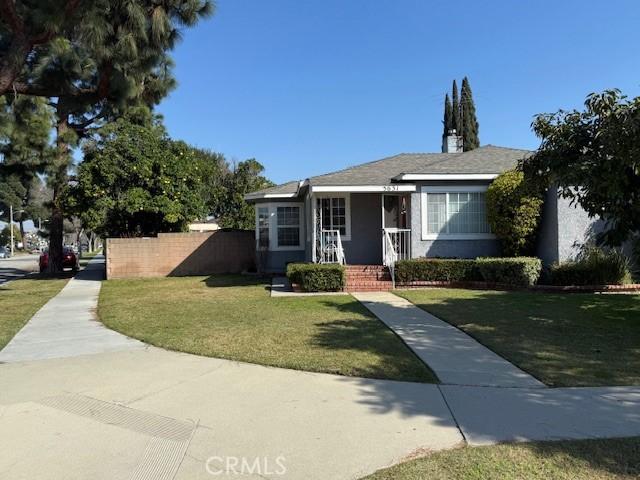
343,193 -> 382,265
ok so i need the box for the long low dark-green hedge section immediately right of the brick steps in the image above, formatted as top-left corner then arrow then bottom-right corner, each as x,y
395,258 -> 482,283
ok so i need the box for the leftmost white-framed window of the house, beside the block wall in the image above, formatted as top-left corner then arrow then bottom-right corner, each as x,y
256,203 -> 304,250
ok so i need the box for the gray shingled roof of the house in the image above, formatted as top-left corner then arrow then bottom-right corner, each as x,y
248,145 -> 533,198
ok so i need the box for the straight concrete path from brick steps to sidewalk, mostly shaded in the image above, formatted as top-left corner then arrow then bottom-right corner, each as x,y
353,292 -> 545,388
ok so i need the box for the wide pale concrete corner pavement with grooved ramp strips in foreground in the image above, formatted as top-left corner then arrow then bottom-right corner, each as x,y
0,347 -> 463,480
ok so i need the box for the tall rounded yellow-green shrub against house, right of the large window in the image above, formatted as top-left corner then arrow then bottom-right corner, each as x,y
487,170 -> 544,257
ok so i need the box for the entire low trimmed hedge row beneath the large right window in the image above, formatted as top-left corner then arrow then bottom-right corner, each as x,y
395,257 -> 542,286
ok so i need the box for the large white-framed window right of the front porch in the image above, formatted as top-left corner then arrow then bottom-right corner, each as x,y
421,186 -> 494,240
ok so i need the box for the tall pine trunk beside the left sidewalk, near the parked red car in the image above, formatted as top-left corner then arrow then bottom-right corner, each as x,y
47,110 -> 69,273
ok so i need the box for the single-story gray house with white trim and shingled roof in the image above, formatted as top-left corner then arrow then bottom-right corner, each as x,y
245,136 -> 594,272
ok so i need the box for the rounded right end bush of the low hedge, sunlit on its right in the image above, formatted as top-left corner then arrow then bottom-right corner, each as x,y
476,257 -> 542,287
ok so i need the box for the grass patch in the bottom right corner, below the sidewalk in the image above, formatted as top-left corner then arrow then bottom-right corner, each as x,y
366,437 -> 640,480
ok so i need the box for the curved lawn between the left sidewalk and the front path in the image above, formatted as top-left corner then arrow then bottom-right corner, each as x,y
98,276 -> 436,382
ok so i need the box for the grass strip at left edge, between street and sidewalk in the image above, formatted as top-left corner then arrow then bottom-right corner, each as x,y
0,277 -> 69,349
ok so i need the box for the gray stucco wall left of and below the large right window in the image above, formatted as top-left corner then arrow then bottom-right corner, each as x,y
411,182 -> 500,258
